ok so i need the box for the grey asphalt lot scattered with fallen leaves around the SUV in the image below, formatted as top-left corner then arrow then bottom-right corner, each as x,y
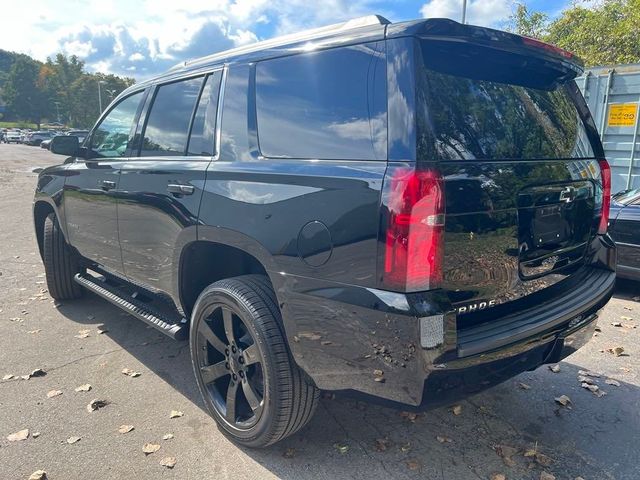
0,144 -> 640,480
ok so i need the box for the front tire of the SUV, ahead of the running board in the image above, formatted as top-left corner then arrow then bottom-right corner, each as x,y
43,213 -> 82,300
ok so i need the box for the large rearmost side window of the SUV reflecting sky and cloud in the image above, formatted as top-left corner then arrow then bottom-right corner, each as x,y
256,42 -> 387,160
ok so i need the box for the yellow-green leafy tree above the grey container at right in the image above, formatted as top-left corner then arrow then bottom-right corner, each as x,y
543,0 -> 640,66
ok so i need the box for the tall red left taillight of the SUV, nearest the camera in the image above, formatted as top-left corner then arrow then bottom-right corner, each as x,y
382,167 -> 444,292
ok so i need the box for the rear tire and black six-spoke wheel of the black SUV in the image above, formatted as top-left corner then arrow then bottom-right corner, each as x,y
189,275 -> 320,448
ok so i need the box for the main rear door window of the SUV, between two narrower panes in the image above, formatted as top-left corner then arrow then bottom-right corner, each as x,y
140,77 -> 203,157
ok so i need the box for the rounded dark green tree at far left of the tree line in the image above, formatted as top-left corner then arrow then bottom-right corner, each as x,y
2,57 -> 50,128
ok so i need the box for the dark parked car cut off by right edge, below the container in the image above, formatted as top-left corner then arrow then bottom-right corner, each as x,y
609,188 -> 640,281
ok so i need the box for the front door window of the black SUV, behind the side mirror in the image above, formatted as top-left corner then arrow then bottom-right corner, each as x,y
90,92 -> 144,158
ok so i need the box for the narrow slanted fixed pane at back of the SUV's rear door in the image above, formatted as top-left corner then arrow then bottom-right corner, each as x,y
187,70 -> 222,156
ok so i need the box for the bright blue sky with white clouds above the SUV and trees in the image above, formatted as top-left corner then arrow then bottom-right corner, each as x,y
0,0 -> 570,79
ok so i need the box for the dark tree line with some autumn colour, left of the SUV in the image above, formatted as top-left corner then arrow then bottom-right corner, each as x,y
0,51 -> 134,128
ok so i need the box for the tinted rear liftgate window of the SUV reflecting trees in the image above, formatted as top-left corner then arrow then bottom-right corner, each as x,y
417,41 -> 594,161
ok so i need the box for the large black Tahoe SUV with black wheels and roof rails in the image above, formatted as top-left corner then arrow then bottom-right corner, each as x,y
34,17 -> 615,446
